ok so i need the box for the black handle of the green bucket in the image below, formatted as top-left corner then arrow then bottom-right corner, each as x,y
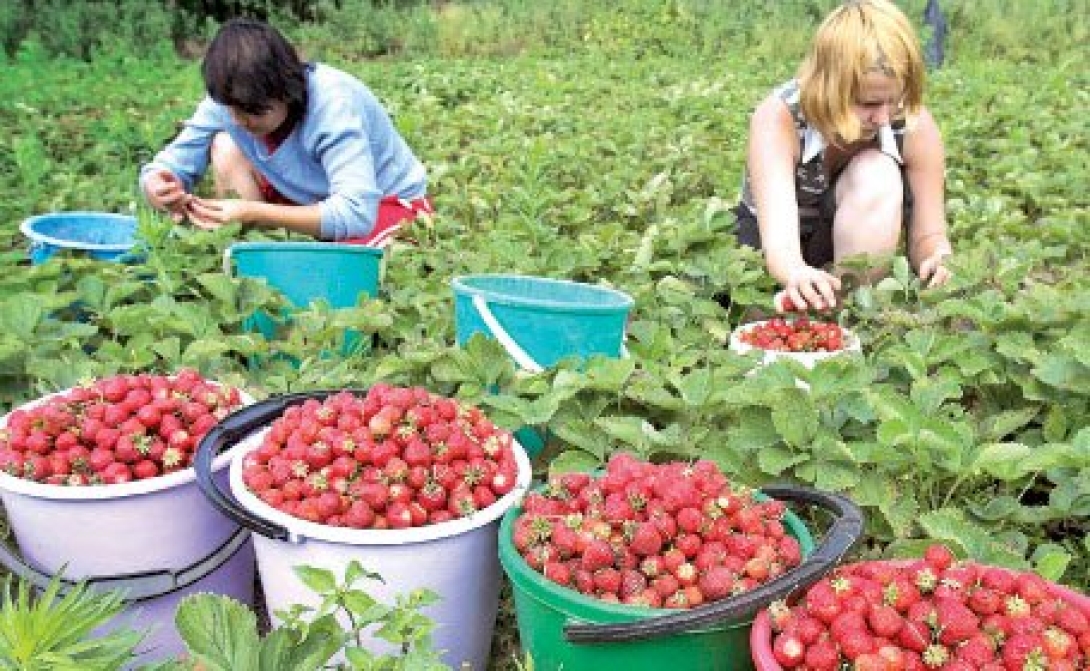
564,485 -> 863,643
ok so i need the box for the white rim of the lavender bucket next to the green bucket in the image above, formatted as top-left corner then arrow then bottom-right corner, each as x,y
228,427 -> 532,546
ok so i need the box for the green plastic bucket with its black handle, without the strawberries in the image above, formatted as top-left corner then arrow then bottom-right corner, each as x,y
499,487 -> 863,671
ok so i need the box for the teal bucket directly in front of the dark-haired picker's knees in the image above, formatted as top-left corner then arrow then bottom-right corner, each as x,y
223,242 -> 383,353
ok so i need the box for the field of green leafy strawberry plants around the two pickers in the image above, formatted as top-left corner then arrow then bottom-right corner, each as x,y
0,0 -> 1090,669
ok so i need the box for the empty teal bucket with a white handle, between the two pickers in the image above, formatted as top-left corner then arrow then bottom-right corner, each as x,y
451,275 -> 634,456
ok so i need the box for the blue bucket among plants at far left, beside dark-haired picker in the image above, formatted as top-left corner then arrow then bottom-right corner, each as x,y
20,211 -> 136,265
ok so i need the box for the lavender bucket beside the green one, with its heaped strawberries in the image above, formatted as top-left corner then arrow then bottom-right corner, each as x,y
196,383 -> 531,669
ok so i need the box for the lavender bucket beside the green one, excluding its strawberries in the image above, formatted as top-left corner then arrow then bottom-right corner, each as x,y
194,391 -> 531,670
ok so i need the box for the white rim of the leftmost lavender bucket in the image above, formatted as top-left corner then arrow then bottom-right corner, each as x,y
0,382 -> 254,501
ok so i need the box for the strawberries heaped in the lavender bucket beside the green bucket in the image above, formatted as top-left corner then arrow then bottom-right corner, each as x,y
242,383 -> 519,529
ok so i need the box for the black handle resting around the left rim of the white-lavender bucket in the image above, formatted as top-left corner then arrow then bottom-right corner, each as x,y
193,389 -> 366,542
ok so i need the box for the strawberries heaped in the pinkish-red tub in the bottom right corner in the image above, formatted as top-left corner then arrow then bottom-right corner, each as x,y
768,545 -> 1090,671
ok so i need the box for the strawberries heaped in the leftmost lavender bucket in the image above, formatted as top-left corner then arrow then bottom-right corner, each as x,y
0,369 -> 241,486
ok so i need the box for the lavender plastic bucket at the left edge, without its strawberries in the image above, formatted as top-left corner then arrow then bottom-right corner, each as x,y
0,385 -> 254,663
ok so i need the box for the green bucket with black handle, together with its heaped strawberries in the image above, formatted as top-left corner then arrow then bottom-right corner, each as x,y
499,453 -> 863,671
